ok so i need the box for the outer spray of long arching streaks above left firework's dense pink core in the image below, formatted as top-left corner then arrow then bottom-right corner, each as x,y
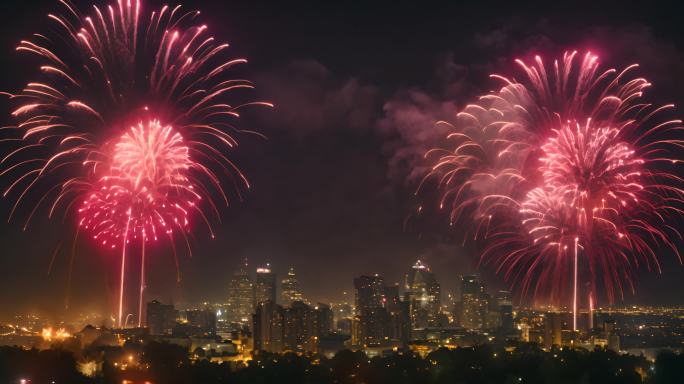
2,0 -> 270,224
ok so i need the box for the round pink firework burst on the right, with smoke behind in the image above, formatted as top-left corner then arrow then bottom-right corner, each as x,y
421,52 -> 684,314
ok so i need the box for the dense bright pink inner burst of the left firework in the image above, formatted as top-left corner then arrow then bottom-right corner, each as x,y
79,121 -> 200,248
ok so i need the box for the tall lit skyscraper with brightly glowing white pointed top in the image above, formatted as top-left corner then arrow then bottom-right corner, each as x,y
404,260 -> 441,328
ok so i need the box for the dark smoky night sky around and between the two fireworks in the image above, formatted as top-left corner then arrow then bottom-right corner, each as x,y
0,0 -> 684,316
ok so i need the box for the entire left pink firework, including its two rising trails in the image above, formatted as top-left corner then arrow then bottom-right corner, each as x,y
0,0 -> 271,324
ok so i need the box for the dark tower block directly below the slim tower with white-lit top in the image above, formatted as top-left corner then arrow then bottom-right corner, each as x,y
252,301 -> 284,353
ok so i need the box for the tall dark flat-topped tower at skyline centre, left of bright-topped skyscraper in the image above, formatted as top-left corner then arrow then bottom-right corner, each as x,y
352,275 -> 389,346
